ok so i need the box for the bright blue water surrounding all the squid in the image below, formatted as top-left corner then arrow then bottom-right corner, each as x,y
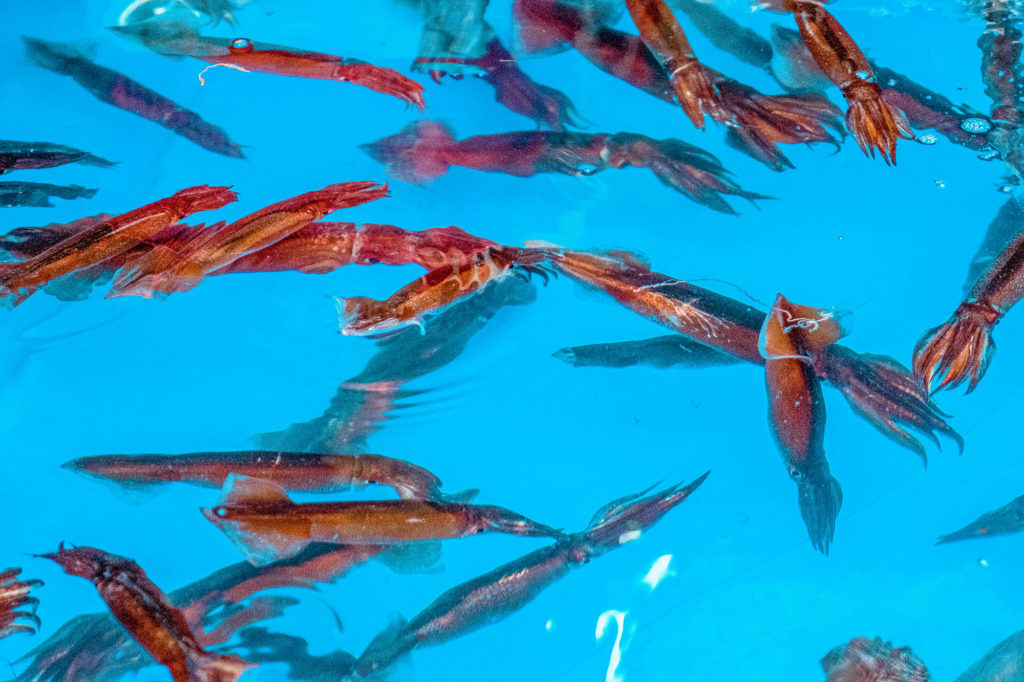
0,0 -> 1024,682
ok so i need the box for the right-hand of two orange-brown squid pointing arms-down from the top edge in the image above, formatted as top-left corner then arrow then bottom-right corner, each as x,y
764,0 -> 913,165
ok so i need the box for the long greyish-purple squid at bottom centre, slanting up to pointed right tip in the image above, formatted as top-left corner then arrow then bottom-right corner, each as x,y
348,472 -> 710,680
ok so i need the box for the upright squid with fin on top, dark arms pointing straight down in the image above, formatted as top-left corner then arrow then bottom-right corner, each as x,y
759,294 -> 843,556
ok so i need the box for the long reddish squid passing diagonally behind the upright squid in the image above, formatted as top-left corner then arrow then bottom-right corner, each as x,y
534,244 -> 964,458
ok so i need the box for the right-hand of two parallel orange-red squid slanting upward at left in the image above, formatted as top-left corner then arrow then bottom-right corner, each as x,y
106,181 -> 387,298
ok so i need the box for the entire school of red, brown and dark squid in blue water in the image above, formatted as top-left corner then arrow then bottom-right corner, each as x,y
6,0 -> 1024,682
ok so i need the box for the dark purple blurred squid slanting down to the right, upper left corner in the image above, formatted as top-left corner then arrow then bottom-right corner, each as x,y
22,36 -> 244,159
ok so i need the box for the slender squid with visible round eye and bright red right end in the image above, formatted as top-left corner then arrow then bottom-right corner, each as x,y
111,22 -> 426,112
